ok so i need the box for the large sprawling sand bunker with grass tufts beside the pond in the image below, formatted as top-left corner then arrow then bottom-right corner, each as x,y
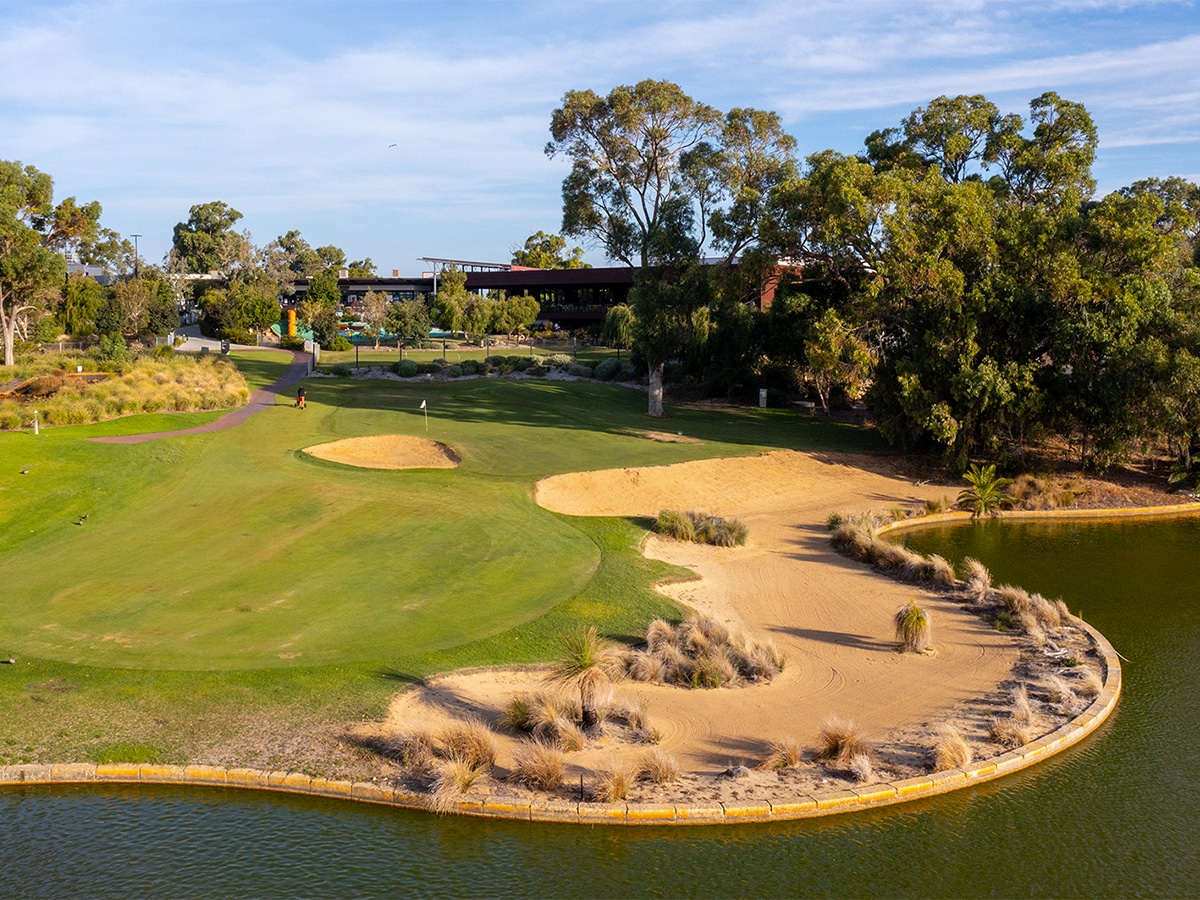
367,451 -> 1019,796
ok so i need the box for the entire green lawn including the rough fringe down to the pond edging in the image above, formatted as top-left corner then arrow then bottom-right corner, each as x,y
0,353 -> 878,764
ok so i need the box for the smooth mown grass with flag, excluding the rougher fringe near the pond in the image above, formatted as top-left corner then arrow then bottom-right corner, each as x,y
0,354 -> 883,670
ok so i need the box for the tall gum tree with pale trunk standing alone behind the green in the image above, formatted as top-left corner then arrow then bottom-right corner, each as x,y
546,79 -> 794,416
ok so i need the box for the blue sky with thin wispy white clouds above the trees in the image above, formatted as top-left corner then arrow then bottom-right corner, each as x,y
0,0 -> 1200,275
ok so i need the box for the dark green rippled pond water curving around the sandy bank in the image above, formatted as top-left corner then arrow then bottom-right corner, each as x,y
0,521 -> 1200,896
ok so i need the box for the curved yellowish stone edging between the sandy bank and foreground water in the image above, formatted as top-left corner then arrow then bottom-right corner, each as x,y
0,620 -> 1121,824
